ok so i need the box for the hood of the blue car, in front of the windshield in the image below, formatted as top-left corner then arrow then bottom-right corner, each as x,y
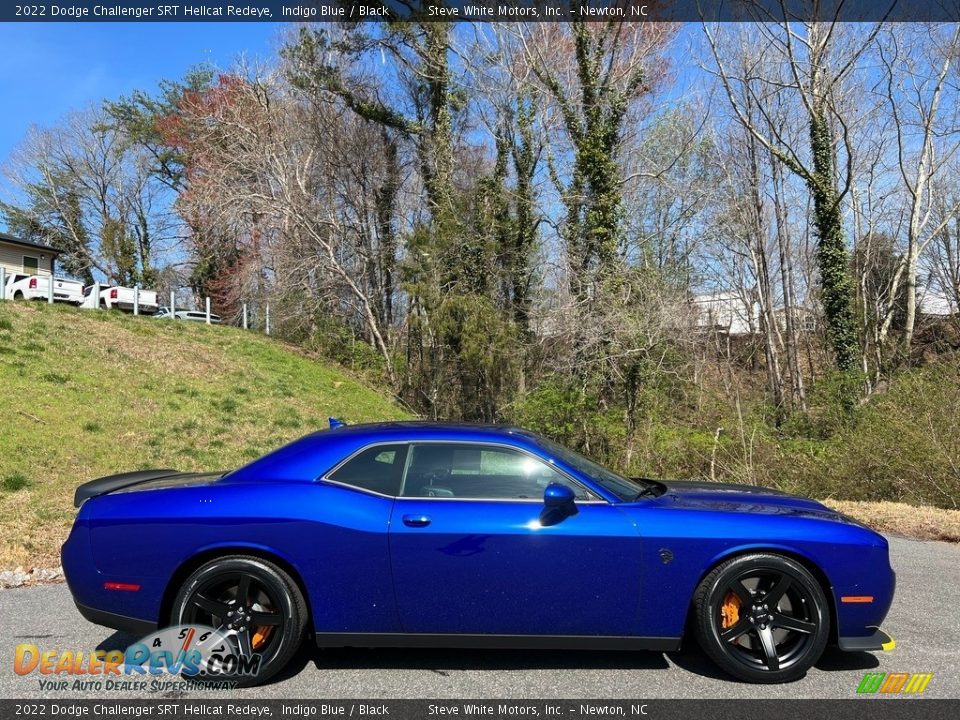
659,480 -> 850,522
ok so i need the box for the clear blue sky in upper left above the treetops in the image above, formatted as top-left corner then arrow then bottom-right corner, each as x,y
0,22 -> 283,169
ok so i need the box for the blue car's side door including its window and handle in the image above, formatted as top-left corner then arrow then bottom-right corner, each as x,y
390,442 -> 641,635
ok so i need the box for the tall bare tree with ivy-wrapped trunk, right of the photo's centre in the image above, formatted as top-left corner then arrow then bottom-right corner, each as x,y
704,16 -> 881,390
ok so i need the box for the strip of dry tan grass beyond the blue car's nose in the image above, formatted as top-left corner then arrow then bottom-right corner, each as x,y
822,500 -> 960,542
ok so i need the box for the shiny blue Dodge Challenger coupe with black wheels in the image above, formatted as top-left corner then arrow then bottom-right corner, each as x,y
62,422 -> 894,684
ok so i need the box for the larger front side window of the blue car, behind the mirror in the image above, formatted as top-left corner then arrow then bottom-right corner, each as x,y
403,443 -> 594,500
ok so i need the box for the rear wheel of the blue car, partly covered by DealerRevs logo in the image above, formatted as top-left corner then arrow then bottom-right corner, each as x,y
170,555 -> 308,687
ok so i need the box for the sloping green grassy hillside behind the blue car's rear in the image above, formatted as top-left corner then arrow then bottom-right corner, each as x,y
0,302 -> 407,568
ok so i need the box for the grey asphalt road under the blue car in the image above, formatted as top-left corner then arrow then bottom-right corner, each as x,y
0,538 -> 960,699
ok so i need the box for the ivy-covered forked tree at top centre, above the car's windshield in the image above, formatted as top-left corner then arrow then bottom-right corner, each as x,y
515,22 -> 675,299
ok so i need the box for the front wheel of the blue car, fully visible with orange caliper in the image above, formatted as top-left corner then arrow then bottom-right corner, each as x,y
694,553 -> 830,683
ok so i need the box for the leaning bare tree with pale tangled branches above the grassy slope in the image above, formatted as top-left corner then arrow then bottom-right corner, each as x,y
173,72 -> 394,381
